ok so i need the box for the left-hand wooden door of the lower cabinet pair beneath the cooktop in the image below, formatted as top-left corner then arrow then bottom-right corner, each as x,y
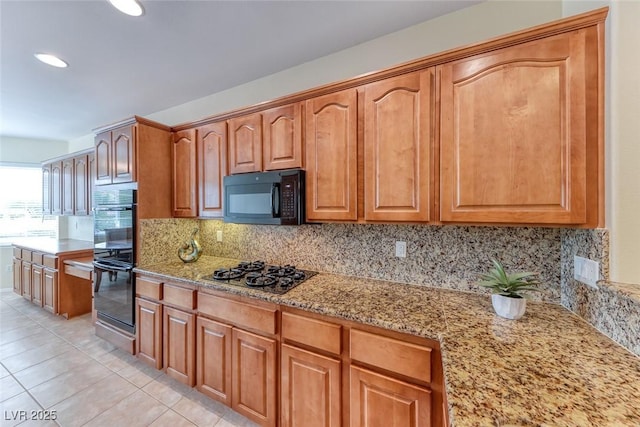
196,317 -> 232,406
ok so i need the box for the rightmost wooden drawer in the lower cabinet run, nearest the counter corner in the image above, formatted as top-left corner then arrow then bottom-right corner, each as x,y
350,329 -> 431,383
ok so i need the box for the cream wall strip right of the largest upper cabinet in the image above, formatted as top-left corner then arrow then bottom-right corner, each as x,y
562,0 -> 640,284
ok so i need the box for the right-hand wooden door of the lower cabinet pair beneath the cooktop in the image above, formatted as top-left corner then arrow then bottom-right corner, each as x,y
232,329 -> 277,426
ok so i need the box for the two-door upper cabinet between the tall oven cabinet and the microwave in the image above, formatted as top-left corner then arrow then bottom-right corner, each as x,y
172,121 -> 227,218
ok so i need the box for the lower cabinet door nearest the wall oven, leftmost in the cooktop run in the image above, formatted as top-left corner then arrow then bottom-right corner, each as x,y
136,298 -> 162,369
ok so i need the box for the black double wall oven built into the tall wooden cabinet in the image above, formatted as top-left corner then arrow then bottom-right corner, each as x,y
93,184 -> 137,333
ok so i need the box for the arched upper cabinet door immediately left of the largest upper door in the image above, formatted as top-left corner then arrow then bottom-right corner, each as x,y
364,69 -> 433,221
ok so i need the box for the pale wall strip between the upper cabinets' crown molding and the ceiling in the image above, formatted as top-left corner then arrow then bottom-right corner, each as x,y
140,1 -> 562,126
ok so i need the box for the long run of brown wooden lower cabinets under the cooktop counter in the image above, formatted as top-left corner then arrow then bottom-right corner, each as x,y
136,275 -> 447,427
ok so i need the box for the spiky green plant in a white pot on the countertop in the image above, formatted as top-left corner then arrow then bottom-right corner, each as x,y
478,259 -> 540,320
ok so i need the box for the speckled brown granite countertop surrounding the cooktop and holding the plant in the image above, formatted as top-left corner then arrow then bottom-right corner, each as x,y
135,256 -> 640,427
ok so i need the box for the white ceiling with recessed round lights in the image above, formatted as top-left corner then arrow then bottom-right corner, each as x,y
0,0 -> 478,140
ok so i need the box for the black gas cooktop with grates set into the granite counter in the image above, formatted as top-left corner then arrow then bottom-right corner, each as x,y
212,261 -> 318,294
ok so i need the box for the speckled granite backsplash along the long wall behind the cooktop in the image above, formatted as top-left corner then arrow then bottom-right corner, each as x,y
140,219 -> 561,304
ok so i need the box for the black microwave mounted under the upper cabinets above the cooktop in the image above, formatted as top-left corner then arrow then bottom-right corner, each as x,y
223,169 -> 305,225
